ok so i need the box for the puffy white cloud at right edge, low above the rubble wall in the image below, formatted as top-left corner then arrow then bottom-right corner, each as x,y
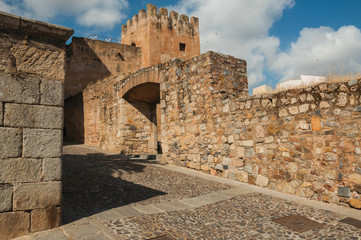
270,26 -> 361,81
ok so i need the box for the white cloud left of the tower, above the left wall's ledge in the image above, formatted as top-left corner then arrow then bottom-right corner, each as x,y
0,0 -> 128,29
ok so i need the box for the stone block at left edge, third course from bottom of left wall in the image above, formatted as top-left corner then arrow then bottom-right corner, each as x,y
0,158 -> 42,183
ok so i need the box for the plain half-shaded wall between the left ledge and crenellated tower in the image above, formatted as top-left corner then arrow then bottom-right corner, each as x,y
65,37 -> 142,99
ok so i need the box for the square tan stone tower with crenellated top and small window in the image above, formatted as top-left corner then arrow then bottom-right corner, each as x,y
122,4 -> 200,67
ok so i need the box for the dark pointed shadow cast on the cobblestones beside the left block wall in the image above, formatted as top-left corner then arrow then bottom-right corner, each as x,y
62,153 -> 167,224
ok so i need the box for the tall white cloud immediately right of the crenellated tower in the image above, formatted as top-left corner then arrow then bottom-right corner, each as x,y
170,0 -> 294,88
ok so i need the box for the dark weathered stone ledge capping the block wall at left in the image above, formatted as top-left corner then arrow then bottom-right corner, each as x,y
0,11 -> 74,41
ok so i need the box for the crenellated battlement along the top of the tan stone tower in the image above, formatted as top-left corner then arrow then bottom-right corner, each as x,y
122,4 -> 199,39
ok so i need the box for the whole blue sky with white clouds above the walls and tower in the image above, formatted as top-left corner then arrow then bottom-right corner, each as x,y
0,0 -> 361,88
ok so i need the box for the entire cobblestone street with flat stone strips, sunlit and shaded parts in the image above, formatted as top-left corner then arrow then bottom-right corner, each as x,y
15,145 -> 361,240
